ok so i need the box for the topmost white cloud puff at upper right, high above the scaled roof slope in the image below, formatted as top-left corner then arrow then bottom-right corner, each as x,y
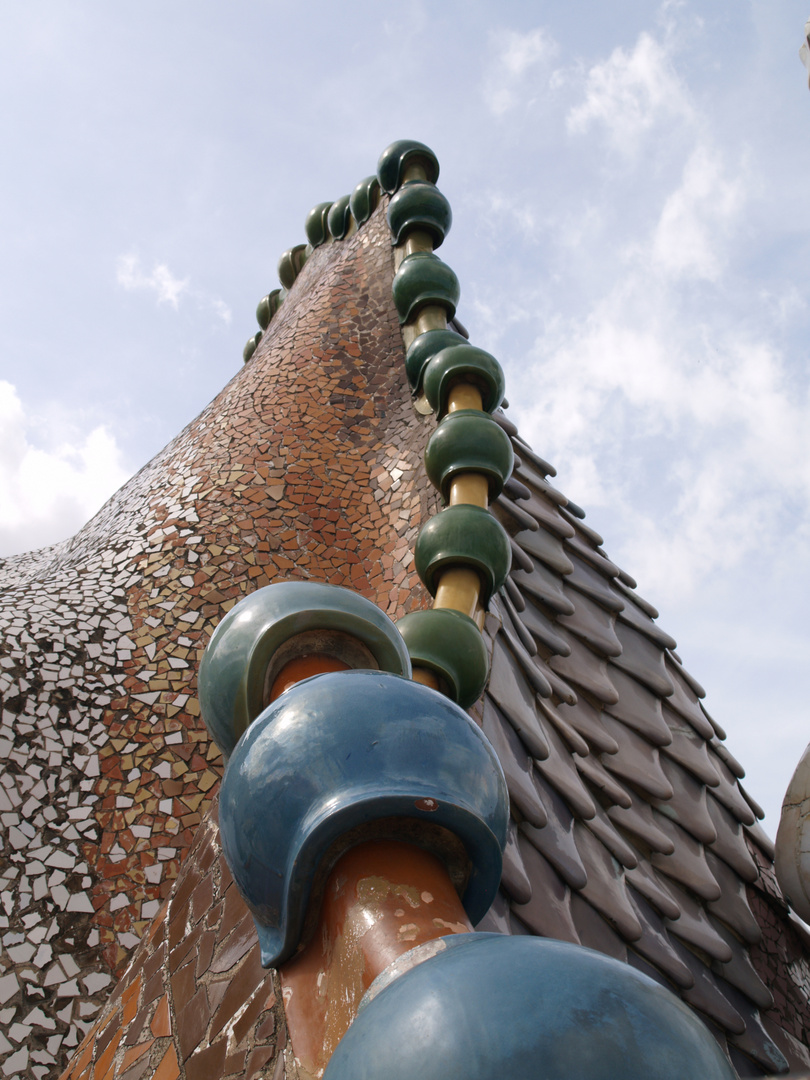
567,32 -> 692,156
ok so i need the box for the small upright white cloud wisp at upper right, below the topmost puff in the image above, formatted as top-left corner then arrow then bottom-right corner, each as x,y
652,145 -> 746,281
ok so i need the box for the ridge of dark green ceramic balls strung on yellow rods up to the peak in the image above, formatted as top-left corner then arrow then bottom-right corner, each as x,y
377,140 -> 514,707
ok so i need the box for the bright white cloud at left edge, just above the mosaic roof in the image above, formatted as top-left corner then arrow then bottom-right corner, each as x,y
0,380 -> 129,555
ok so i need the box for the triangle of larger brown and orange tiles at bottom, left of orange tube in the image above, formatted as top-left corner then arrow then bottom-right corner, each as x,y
55,807 -> 286,1080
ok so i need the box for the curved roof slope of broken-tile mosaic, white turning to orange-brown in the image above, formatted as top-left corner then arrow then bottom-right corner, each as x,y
0,204 -> 434,1080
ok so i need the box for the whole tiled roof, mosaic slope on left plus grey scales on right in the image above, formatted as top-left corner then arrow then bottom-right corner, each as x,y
0,145 -> 810,1080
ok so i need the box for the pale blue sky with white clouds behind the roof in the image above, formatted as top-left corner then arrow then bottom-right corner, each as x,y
0,0 -> 810,836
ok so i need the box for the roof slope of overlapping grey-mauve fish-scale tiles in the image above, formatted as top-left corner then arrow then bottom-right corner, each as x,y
477,425 -> 810,1076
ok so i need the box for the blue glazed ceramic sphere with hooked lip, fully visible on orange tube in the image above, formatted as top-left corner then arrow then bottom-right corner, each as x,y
219,671 -> 509,967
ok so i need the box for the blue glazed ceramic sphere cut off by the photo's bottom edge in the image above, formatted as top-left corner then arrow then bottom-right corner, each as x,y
324,934 -> 735,1080
